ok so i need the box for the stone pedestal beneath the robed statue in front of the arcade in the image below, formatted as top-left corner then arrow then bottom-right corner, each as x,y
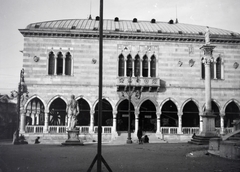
62,130 -> 83,146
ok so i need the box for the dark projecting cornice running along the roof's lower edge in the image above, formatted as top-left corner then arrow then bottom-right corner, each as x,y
19,29 -> 240,44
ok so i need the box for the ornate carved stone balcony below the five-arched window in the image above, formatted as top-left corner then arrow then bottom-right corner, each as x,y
116,76 -> 160,91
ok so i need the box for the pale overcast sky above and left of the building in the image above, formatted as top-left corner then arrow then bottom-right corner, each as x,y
0,0 -> 240,95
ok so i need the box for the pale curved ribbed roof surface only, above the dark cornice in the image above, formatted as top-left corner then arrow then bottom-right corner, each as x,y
27,18 -> 240,35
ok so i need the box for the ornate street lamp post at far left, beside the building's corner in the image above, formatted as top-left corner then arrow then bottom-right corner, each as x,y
11,69 -> 28,144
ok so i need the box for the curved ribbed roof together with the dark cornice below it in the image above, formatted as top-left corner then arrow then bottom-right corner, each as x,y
19,17 -> 240,44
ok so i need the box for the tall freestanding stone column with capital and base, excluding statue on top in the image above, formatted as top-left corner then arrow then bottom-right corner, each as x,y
200,44 -> 216,137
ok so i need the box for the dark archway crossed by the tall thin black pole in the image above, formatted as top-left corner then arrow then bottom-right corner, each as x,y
94,99 -> 113,126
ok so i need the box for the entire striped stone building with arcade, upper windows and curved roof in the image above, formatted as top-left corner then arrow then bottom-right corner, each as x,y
17,17 -> 240,143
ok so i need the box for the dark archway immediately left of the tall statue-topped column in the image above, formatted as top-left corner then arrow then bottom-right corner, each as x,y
182,100 -> 199,127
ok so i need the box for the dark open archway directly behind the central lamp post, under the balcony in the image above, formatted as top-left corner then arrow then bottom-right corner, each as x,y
117,100 -> 135,131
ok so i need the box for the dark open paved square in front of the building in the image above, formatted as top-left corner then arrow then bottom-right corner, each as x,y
0,142 -> 240,172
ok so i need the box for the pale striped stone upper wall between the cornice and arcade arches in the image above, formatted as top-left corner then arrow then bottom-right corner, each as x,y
23,37 -> 240,111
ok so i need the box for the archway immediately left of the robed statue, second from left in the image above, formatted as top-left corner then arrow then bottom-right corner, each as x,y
49,98 -> 66,125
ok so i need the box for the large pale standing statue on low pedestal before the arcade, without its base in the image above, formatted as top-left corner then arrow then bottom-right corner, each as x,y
66,95 -> 79,130
